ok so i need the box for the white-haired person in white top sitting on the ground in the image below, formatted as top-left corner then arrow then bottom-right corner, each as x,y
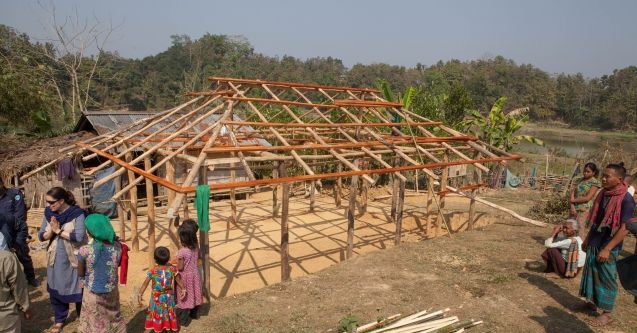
542,219 -> 586,278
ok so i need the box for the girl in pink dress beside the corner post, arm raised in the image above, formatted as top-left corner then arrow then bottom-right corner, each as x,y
177,223 -> 202,326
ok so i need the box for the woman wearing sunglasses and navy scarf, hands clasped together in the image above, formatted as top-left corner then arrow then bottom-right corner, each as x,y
38,187 -> 86,333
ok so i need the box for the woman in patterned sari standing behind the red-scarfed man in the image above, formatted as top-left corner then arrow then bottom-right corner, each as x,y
570,162 -> 602,232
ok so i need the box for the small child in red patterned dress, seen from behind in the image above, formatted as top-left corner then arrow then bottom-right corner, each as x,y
138,246 -> 186,332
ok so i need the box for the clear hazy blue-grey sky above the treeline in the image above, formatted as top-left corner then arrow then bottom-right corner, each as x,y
0,0 -> 637,77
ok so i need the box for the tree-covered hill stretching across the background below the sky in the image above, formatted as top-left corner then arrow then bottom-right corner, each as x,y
0,25 -> 637,134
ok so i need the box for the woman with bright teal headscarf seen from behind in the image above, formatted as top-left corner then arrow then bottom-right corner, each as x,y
77,214 -> 126,333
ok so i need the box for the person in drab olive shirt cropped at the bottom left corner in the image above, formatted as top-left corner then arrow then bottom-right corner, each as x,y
0,250 -> 31,333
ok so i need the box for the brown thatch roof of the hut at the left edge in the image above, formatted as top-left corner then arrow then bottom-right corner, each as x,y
0,132 -> 95,178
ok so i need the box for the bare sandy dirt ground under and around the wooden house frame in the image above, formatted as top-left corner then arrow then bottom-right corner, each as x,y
26,188 -> 637,332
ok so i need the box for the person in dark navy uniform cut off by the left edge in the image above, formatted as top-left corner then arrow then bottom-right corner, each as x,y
0,177 -> 39,287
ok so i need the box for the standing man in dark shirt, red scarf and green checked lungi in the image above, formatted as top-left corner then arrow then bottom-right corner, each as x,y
579,163 -> 635,326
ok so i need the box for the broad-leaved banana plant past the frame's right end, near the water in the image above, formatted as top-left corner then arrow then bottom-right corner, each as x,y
462,97 -> 544,151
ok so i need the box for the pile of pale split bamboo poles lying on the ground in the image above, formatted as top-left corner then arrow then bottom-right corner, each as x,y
355,309 -> 482,333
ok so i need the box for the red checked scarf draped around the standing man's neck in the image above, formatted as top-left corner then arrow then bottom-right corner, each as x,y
588,183 -> 628,236
